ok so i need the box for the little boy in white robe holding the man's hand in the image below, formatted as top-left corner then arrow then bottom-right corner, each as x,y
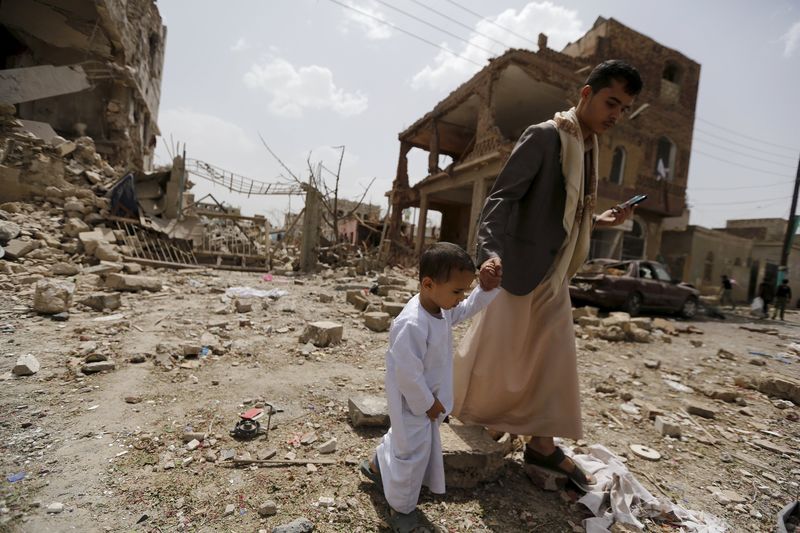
360,242 -> 501,531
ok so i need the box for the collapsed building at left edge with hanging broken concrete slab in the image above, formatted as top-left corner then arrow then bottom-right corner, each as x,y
0,0 -> 167,170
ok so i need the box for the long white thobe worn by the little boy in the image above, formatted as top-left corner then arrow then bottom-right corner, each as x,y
376,287 -> 500,513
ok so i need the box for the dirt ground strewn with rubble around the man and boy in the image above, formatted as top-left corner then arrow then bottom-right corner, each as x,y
0,270 -> 800,533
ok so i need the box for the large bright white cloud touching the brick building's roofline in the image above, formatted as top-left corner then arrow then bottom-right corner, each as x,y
411,2 -> 584,90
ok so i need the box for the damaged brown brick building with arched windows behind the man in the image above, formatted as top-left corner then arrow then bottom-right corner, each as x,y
389,17 -> 700,259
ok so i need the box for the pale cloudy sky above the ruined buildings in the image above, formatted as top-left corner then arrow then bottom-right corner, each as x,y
157,0 -> 800,227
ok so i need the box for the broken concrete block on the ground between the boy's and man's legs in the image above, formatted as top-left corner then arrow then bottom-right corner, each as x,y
440,417 -> 510,488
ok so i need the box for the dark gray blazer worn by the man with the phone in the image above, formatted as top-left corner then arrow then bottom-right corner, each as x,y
477,122 -> 567,296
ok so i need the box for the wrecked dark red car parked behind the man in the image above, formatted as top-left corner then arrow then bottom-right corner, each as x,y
569,259 -> 700,318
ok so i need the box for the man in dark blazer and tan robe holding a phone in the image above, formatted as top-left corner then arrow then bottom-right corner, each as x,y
453,60 -> 642,487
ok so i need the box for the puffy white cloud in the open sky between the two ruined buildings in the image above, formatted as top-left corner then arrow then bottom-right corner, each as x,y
244,58 -> 367,118
